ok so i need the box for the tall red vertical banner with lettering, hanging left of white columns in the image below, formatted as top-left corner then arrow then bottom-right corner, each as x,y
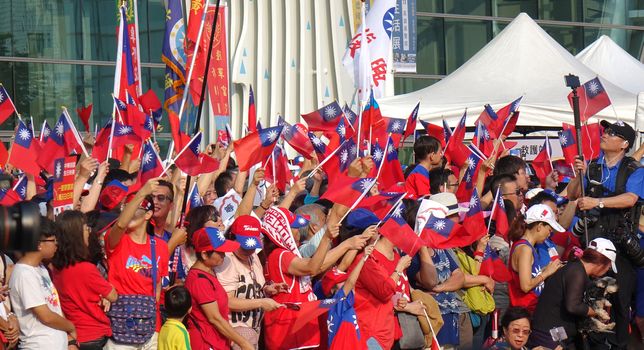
207,6 -> 230,116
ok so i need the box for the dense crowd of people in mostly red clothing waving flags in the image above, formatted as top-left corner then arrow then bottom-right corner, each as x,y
0,117 -> 644,350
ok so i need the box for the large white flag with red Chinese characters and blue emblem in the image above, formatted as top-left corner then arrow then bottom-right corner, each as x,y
342,0 -> 396,97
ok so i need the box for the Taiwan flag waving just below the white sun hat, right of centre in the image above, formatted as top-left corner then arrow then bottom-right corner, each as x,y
421,215 -> 472,249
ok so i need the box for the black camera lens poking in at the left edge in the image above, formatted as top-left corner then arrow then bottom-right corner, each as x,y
0,174 -> 40,252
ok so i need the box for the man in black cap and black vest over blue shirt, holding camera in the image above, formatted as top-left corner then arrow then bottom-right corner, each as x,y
567,120 -> 644,349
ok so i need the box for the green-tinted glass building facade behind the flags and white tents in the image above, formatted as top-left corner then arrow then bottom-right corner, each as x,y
0,0 -> 644,140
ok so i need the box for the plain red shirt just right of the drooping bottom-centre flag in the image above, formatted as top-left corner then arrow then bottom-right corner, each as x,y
347,250 -> 400,349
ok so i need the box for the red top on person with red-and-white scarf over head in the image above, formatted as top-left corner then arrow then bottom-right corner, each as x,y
264,248 -> 320,350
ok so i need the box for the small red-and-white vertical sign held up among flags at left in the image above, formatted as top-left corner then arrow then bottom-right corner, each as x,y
51,156 -> 76,216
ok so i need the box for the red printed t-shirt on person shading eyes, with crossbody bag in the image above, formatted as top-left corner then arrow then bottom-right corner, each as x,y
105,232 -> 169,332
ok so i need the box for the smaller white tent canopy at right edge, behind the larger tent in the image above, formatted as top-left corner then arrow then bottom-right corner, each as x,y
575,35 -> 644,94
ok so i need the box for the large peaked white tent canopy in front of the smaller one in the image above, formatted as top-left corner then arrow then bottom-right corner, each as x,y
378,13 -> 636,127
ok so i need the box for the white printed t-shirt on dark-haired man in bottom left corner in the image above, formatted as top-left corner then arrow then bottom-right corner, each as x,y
9,263 -> 67,350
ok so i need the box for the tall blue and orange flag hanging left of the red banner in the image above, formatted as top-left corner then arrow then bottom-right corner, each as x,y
161,0 -> 186,113
